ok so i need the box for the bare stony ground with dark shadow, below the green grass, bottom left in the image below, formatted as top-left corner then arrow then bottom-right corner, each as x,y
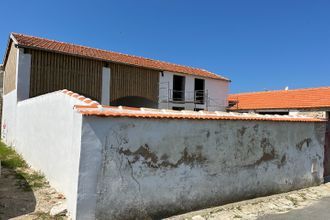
0,167 -> 67,220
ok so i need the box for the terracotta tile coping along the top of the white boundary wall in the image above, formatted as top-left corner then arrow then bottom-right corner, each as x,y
62,89 -> 324,122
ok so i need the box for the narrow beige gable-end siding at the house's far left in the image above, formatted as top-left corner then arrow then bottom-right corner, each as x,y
3,42 -> 17,95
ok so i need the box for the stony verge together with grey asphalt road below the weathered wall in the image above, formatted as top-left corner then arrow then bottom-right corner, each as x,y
168,183 -> 330,220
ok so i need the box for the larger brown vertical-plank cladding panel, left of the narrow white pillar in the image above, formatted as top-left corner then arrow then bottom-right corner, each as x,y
26,49 -> 104,101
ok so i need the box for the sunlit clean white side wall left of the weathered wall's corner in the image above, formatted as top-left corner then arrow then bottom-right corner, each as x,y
15,92 -> 84,218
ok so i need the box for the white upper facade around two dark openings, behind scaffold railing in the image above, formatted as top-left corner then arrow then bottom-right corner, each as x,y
158,71 -> 229,111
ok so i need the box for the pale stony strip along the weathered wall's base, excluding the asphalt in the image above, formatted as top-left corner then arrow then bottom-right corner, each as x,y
168,183 -> 330,220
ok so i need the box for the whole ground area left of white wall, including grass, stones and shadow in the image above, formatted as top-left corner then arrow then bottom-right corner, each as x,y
0,142 -> 67,220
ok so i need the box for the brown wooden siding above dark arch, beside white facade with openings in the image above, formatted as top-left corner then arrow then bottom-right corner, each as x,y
110,63 -> 159,107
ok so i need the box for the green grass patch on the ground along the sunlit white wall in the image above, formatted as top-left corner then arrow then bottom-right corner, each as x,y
0,142 -> 47,191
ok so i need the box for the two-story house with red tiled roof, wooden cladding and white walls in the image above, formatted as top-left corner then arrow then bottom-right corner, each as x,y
2,33 -> 230,144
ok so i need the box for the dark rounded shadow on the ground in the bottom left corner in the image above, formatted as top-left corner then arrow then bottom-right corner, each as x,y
0,167 -> 36,219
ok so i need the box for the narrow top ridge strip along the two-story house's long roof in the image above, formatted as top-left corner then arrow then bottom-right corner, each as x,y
11,32 -> 228,80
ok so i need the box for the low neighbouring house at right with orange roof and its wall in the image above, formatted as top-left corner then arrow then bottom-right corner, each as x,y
228,87 -> 330,179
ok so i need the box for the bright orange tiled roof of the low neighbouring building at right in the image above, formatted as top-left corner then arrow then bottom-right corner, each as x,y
228,87 -> 330,110
